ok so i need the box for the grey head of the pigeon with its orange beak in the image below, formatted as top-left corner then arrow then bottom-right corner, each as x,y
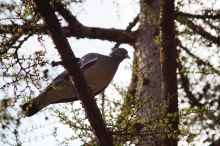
110,48 -> 130,62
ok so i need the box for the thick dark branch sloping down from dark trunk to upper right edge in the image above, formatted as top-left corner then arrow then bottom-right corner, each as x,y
176,17 -> 220,45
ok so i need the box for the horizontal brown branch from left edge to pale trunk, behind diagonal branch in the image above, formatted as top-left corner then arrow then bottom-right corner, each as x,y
0,24 -> 137,44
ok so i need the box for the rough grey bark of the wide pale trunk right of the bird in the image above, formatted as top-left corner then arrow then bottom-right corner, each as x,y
136,0 -> 162,146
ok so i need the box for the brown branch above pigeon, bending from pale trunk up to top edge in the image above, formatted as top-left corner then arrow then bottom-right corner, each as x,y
53,1 -> 136,44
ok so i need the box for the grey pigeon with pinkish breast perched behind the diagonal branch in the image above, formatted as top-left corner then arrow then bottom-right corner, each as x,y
21,48 -> 130,117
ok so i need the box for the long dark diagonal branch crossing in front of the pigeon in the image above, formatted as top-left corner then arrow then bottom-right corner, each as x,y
34,0 -> 113,146
